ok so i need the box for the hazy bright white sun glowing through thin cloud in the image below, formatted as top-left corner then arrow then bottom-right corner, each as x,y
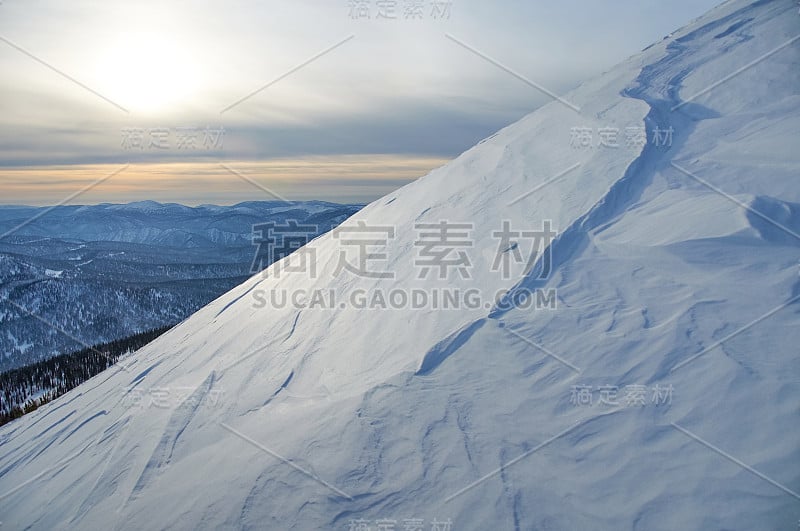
97,32 -> 199,114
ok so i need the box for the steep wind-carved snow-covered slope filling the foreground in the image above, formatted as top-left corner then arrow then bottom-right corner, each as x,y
0,0 -> 800,530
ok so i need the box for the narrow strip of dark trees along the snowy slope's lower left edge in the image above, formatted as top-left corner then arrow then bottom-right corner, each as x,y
0,325 -> 174,426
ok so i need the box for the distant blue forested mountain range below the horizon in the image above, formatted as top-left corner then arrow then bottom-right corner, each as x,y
0,201 -> 361,370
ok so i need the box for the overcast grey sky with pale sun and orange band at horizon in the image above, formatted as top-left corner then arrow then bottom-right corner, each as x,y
0,0 -> 718,204
